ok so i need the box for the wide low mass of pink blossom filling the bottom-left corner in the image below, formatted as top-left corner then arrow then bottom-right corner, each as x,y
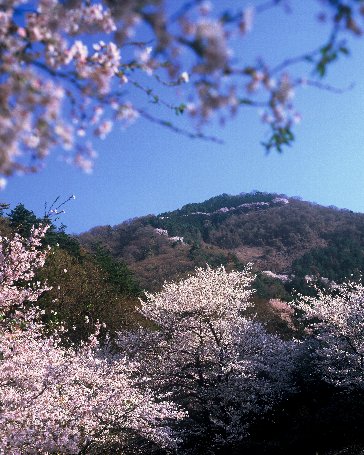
0,321 -> 184,454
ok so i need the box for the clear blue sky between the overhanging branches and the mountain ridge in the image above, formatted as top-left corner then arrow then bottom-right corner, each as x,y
1,1 -> 364,233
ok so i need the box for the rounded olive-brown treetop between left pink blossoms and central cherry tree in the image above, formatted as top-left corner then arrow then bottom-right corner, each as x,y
38,248 -> 140,343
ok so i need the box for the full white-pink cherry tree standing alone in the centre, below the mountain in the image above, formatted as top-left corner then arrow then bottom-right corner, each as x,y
119,267 -> 295,453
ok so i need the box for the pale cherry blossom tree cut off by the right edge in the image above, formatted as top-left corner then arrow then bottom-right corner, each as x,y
295,281 -> 364,390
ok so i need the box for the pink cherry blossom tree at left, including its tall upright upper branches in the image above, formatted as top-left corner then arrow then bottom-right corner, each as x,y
0,227 -> 185,455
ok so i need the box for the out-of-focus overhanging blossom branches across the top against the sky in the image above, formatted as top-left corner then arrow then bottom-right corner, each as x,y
0,0 -> 363,182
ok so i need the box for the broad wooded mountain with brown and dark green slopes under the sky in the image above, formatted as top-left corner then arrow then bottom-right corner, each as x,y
79,191 -> 364,290
